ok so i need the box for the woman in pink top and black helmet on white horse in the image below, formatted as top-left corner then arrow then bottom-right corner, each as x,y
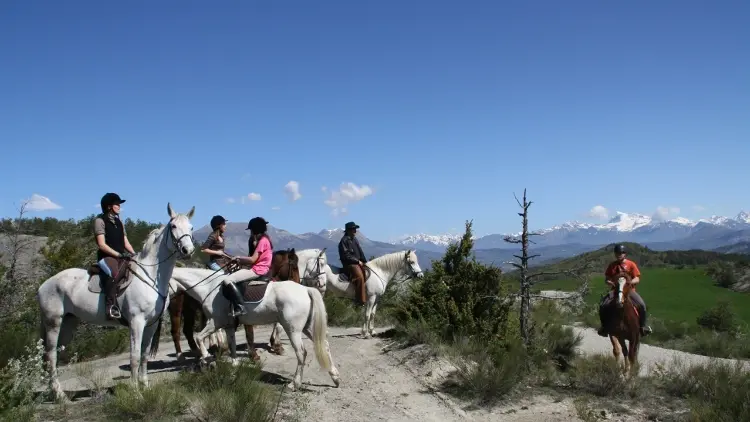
223,217 -> 273,316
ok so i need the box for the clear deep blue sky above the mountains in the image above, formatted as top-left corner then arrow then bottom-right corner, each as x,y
0,0 -> 750,239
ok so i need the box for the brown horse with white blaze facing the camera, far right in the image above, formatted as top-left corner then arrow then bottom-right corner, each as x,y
606,273 -> 641,375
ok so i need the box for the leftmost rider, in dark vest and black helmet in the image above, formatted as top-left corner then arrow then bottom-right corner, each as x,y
94,192 -> 135,319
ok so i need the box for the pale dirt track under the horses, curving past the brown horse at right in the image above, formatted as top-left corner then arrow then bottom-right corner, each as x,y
47,326 -> 750,422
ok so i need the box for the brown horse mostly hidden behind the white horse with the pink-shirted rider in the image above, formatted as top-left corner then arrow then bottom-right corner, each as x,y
167,248 -> 300,361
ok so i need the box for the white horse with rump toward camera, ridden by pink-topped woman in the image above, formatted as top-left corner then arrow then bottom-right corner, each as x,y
173,268 -> 340,391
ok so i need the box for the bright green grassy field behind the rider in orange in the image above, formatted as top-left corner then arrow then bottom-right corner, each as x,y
534,267 -> 750,326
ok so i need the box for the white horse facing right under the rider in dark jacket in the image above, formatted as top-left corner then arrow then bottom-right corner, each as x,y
304,250 -> 424,338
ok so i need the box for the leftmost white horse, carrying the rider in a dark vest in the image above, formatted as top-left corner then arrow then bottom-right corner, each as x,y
36,204 -> 195,400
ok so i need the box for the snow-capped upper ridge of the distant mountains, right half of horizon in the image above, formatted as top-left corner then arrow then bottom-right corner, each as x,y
391,211 -> 750,252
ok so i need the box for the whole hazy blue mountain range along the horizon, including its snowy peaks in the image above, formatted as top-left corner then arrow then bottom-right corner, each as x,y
194,211 -> 750,269
